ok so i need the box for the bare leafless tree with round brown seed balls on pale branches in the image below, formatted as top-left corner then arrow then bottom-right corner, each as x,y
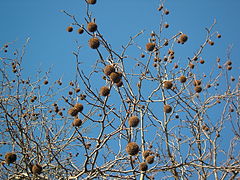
0,0 -> 240,179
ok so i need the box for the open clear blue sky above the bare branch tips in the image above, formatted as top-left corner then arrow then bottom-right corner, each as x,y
0,0 -> 240,179
